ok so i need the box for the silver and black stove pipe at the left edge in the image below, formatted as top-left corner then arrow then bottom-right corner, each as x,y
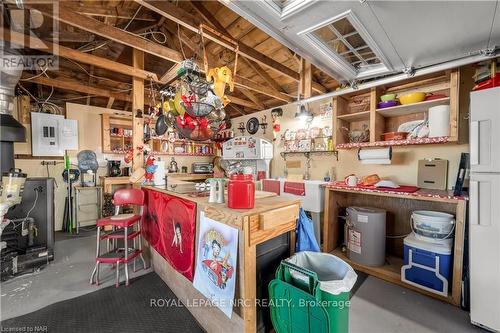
0,41 -> 26,173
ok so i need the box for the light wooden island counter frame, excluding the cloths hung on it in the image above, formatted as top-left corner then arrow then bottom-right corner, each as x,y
144,186 -> 300,333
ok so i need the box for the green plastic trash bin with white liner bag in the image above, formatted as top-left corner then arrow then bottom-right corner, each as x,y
269,251 -> 357,333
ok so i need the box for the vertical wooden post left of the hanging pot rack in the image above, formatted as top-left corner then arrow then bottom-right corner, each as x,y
132,49 -> 144,171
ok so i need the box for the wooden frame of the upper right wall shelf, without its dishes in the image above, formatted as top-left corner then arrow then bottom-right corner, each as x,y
332,67 -> 474,149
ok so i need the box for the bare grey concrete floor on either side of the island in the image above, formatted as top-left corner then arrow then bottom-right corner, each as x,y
0,232 -> 482,333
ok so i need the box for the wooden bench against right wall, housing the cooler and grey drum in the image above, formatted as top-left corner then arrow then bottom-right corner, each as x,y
323,184 -> 467,306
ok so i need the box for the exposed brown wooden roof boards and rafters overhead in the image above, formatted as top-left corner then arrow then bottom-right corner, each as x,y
7,0 -> 335,115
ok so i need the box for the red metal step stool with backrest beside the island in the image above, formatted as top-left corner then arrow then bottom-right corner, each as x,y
90,189 -> 146,287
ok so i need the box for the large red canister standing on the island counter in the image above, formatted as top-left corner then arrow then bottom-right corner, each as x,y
227,174 -> 255,209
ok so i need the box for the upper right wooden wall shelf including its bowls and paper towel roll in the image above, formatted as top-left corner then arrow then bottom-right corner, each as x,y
333,67 -> 474,149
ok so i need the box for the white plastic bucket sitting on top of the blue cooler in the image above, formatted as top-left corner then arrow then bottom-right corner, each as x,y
410,210 -> 455,241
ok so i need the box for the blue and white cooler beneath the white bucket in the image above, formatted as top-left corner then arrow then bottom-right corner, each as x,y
401,233 -> 453,296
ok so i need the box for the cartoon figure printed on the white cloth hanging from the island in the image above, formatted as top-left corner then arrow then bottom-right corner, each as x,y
203,229 -> 234,289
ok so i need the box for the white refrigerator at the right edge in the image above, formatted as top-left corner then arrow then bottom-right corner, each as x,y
469,87 -> 500,331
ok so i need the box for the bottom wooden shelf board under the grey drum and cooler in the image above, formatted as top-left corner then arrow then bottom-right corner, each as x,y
331,248 -> 453,303
